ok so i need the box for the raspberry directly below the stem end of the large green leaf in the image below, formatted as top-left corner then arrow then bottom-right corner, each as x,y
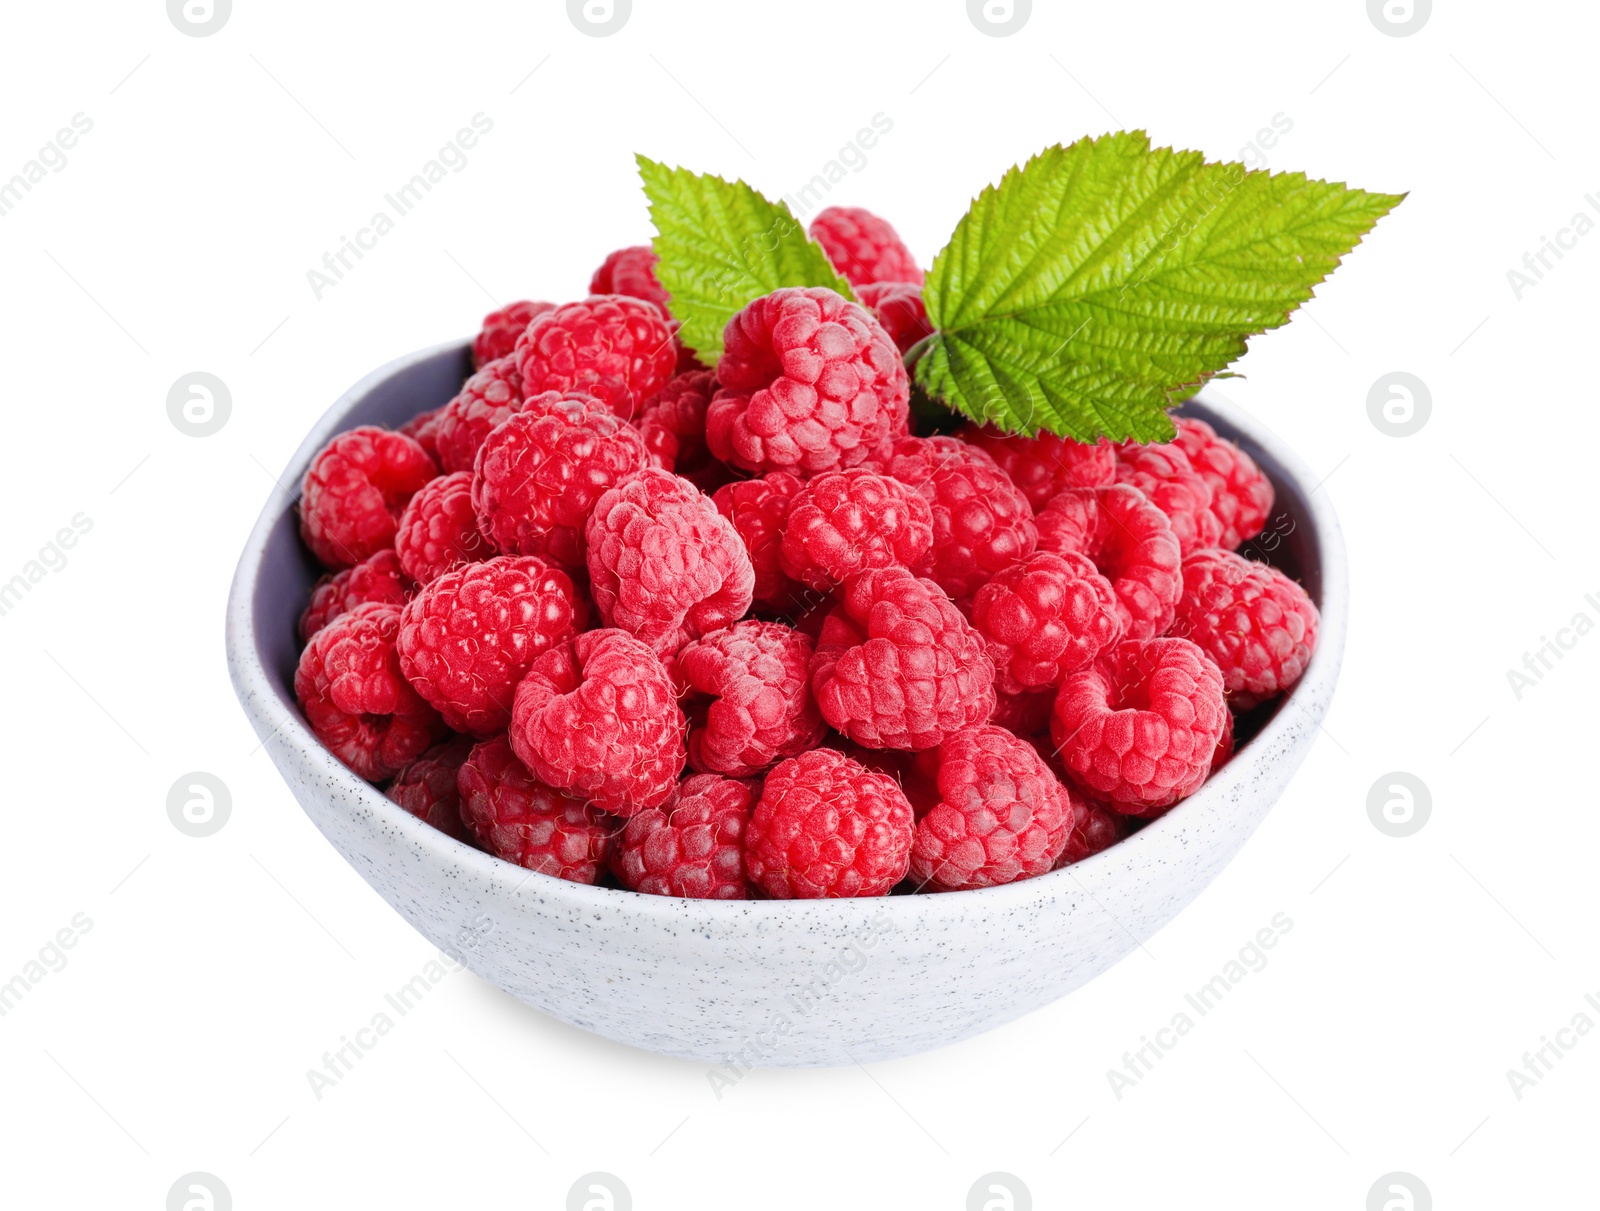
883,437 -> 1038,602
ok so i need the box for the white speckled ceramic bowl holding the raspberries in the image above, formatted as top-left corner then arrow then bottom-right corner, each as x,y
227,344 -> 1347,1078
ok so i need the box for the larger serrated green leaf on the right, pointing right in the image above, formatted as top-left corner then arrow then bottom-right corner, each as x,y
917,131 -> 1405,442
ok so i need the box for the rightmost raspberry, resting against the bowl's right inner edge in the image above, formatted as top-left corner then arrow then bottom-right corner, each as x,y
1171,549 -> 1318,710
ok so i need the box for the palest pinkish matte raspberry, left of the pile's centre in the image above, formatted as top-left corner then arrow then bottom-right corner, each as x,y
584,467 -> 755,656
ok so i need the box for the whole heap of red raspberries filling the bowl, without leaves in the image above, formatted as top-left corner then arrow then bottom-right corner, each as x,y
294,208 -> 1318,899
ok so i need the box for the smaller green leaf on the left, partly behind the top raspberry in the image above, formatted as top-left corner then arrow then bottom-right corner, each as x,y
635,155 -> 854,363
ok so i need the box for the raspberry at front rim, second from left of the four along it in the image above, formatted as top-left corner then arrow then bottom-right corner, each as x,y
611,774 -> 758,899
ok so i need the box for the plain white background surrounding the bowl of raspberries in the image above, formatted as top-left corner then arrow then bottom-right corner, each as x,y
0,0 -> 1600,1211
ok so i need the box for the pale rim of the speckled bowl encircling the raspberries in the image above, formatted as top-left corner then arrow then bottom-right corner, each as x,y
226,341 -> 1349,926
